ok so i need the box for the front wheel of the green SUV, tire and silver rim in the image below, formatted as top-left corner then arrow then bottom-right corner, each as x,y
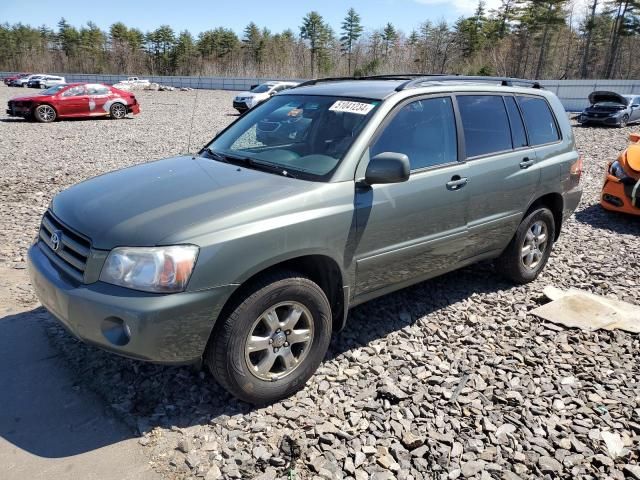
204,271 -> 332,405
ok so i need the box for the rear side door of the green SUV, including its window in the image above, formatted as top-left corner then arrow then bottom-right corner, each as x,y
456,93 -> 540,258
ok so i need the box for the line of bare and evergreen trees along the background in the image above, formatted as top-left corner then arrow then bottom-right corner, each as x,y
0,0 -> 640,79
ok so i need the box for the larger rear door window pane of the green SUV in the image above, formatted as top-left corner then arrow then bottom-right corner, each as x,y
457,95 -> 513,157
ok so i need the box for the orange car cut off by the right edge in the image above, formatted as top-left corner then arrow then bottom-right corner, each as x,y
600,133 -> 640,215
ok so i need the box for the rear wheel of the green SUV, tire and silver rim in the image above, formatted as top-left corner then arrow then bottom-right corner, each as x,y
495,208 -> 556,285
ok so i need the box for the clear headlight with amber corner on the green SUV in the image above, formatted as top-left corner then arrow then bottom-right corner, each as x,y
100,245 -> 198,293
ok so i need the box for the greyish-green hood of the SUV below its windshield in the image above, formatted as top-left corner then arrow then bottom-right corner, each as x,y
51,156 -> 322,250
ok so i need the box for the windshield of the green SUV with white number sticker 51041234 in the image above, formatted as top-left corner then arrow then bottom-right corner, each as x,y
204,95 -> 380,181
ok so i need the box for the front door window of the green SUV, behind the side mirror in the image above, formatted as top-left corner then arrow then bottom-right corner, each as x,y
370,97 -> 458,170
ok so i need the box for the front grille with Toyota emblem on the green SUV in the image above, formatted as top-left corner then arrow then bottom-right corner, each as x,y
40,211 -> 91,282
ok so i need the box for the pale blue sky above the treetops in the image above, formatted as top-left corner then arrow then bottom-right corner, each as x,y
0,0 -> 500,35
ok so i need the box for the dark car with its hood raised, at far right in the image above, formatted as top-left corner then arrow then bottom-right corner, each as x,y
578,91 -> 640,127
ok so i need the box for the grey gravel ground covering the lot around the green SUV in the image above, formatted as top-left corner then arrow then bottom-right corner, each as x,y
0,87 -> 640,480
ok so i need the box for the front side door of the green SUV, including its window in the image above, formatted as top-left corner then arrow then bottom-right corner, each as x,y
355,96 -> 468,296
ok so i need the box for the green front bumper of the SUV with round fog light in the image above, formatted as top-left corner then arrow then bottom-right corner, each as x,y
28,242 -> 235,364
